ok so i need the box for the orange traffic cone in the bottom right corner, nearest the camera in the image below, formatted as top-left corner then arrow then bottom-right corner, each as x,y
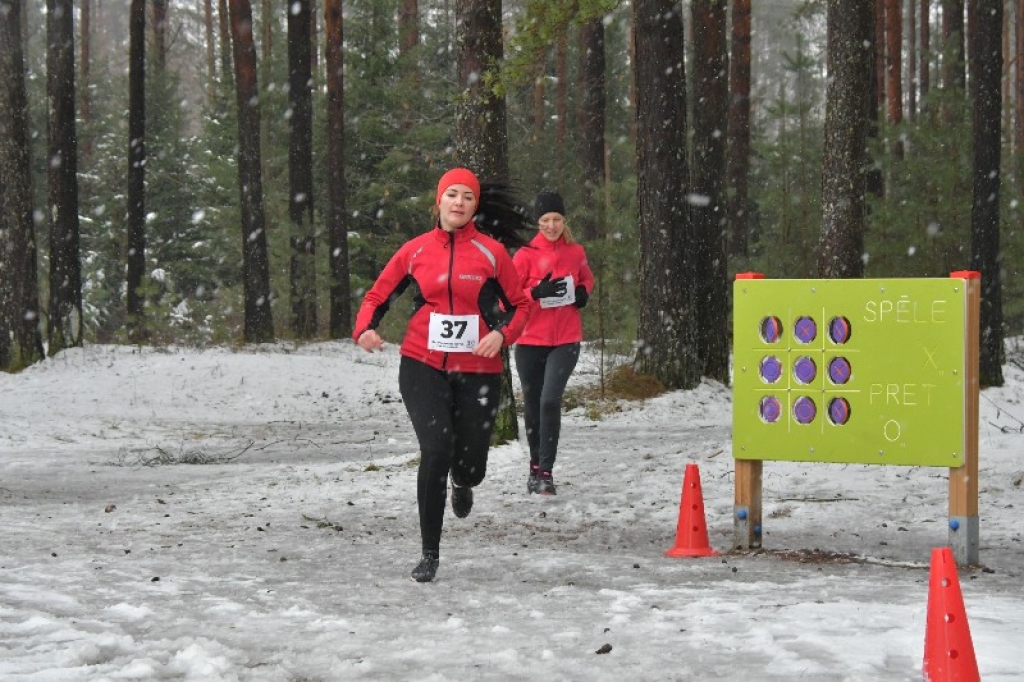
924,547 -> 981,682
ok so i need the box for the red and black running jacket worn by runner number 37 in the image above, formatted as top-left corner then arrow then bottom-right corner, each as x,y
352,222 -> 529,374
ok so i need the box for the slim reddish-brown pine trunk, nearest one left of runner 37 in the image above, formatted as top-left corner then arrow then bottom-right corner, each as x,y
324,0 -> 352,339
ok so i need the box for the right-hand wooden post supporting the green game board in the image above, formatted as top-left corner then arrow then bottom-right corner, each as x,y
949,270 -> 981,566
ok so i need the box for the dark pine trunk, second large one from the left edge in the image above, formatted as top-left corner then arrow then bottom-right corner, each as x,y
46,0 -> 82,355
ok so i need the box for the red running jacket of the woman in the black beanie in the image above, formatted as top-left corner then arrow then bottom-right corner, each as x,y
513,232 -> 594,346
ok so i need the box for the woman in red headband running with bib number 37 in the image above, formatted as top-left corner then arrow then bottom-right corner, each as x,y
352,168 -> 529,583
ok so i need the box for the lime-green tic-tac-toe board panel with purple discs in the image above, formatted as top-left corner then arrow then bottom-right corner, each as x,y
732,279 -> 967,468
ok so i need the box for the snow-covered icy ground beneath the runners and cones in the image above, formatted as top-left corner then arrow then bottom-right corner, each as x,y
0,343 -> 1024,682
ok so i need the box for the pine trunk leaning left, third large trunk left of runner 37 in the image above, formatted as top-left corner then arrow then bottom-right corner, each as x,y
229,0 -> 273,343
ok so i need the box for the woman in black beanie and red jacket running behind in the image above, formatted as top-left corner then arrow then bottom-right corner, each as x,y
513,191 -> 594,495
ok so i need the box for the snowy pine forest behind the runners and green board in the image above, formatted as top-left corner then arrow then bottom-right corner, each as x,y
0,0 -> 1024,387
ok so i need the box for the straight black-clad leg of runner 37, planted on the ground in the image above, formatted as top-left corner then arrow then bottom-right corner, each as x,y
398,356 -> 454,552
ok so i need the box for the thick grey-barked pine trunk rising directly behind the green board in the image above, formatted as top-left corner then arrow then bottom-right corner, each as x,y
818,0 -> 874,279
